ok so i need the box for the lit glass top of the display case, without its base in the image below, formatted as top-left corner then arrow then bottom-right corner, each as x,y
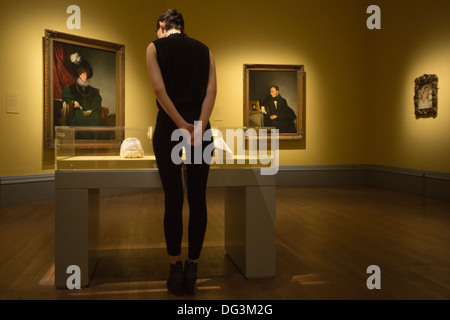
55,126 -> 278,170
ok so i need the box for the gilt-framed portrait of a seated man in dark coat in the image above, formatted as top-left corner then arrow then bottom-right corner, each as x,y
244,64 -> 306,140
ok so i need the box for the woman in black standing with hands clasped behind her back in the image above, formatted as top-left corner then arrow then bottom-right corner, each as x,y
147,9 -> 217,296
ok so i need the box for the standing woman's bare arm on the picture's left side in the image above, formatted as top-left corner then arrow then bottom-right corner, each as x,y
147,43 -> 194,132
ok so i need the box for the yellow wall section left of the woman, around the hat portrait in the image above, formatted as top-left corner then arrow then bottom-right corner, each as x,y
0,0 -> 166,176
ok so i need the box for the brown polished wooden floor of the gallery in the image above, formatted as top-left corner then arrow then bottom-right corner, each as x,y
0,187 -> 450,300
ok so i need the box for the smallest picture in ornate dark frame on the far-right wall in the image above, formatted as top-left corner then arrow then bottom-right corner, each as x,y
414,74 -> 438,118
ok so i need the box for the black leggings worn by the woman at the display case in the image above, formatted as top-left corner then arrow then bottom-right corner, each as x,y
153,113 -> 211,260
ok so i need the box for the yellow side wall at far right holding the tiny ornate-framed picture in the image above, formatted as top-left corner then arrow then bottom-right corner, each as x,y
365,0 -> 450,172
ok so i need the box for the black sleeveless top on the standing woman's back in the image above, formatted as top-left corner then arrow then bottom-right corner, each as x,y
153,33 -> 209,123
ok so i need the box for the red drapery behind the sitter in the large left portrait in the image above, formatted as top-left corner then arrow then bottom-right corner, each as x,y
53,41 -> 76,99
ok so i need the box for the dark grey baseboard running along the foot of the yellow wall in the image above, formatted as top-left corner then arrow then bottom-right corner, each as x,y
0,165 -> 450,207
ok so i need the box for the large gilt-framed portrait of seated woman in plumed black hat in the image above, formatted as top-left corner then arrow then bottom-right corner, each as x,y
44,30 -> 125,149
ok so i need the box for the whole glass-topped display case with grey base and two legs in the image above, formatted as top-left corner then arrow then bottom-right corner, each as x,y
55,127 -> 278,288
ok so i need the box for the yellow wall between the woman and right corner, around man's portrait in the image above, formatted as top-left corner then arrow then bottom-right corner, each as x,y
167,0 -> 366,165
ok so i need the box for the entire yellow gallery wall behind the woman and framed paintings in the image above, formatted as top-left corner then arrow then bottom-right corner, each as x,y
0,0 -> 450,176
